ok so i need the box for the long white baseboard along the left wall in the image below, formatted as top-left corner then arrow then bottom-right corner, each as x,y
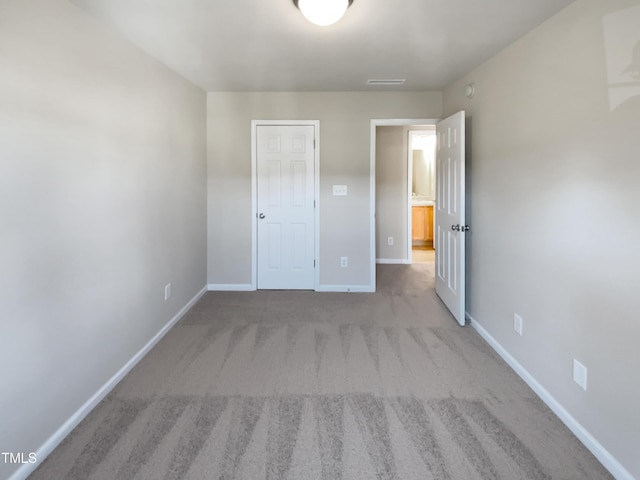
9,288 -> 207,480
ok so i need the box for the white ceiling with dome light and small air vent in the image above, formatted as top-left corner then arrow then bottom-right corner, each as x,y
72,0 -> 573,91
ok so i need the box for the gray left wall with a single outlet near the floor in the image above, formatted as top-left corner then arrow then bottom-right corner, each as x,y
0,0 -> 206,478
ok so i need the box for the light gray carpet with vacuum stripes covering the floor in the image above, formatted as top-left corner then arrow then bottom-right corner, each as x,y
30,264 -> 611,480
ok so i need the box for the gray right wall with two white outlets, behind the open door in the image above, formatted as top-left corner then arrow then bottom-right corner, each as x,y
444,0 -> 640,478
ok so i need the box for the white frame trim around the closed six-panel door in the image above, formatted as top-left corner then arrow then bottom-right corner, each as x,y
251,120 -> 320,291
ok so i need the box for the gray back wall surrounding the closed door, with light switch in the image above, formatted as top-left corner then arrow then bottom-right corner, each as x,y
207,92 -> 442,286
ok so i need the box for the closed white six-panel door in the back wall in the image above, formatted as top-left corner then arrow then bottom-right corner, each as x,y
256,125 -> 315,290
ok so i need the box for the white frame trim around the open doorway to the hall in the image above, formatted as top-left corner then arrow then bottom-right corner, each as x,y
369,118 -> 440,286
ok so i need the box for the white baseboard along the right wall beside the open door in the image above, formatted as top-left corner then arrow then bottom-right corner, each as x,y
466,313 -> 634,480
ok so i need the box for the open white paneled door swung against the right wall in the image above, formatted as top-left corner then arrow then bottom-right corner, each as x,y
435,111 -> 469,325
